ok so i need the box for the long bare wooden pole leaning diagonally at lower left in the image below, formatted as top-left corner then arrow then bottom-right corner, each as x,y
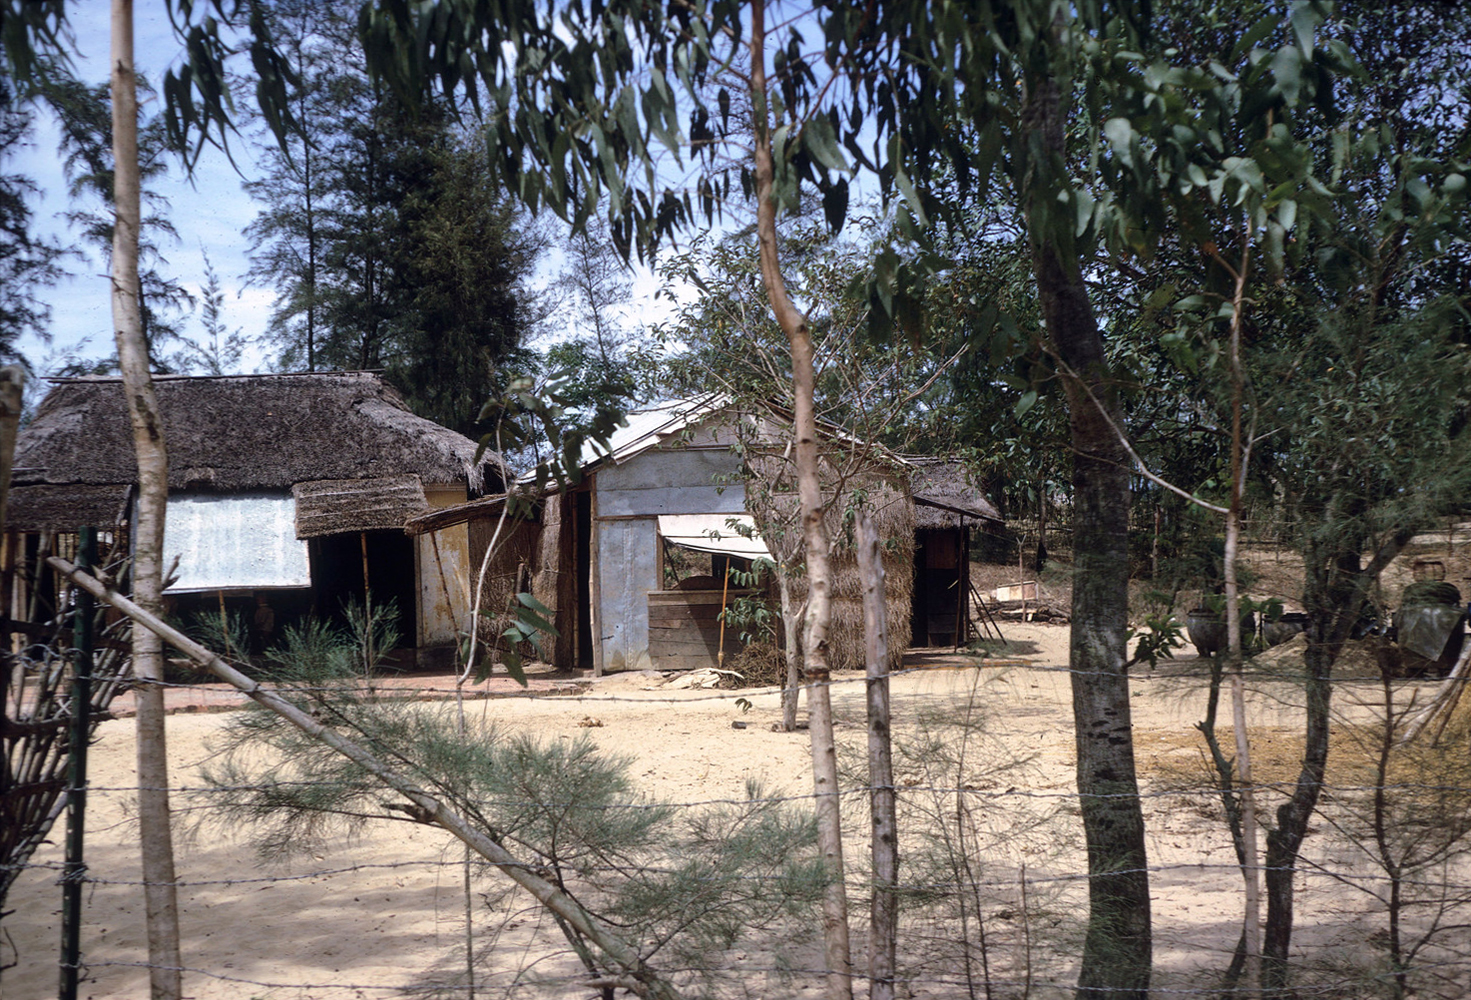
47,556 -> 680,1000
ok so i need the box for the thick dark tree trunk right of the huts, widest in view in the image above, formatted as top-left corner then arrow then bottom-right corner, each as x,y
1022,78 -> 1152,1000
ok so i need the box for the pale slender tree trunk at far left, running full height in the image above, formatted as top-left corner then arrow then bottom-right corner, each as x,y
112,0 -> 182,1000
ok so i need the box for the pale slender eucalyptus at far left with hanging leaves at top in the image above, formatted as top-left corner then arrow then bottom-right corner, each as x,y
0,0 -> 298,999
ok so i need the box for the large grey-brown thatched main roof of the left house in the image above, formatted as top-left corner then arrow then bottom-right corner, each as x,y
15,372 -> 499,497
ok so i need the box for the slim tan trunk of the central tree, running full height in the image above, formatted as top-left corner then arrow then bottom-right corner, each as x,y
750,0 -> 853,1000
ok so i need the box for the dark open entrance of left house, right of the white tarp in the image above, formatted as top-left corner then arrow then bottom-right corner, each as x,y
309,531 -> 419,649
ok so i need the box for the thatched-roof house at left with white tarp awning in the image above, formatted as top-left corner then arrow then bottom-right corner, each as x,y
6,372 -> 503,664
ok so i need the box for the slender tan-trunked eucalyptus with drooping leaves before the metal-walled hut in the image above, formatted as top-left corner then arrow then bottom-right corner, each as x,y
353,0 -> 941,997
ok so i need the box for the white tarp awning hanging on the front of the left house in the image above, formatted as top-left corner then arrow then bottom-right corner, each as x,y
163,494 -> 312,594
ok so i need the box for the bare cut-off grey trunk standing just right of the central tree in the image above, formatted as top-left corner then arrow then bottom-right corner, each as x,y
858,513 -> 899,1000
